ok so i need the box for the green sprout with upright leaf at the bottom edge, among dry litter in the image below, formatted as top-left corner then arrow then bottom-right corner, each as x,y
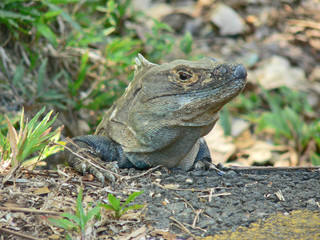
47,186 -> 100,239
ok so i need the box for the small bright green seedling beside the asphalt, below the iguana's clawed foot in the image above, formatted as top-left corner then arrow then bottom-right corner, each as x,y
100,192 -> 143,218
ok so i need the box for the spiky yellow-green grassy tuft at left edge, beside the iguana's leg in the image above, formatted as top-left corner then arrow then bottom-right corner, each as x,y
0,107 -> 62,167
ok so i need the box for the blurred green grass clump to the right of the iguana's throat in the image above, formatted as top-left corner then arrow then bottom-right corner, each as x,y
229,86 -> 320,166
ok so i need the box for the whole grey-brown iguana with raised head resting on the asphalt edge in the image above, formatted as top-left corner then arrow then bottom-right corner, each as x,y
65,54 -> 247,181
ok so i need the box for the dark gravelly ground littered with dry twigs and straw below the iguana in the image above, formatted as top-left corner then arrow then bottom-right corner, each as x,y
0,168 -> 320,239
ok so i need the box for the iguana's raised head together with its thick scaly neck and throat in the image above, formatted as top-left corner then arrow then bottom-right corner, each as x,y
100,54 -> 247,151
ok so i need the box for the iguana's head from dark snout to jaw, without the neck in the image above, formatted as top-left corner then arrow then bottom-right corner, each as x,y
131,55 -> 247,126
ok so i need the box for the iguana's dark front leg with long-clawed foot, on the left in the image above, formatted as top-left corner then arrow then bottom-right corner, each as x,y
65,135 -> 133,183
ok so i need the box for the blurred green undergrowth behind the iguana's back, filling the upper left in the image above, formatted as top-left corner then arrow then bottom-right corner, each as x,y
0,0 -> 192,169
